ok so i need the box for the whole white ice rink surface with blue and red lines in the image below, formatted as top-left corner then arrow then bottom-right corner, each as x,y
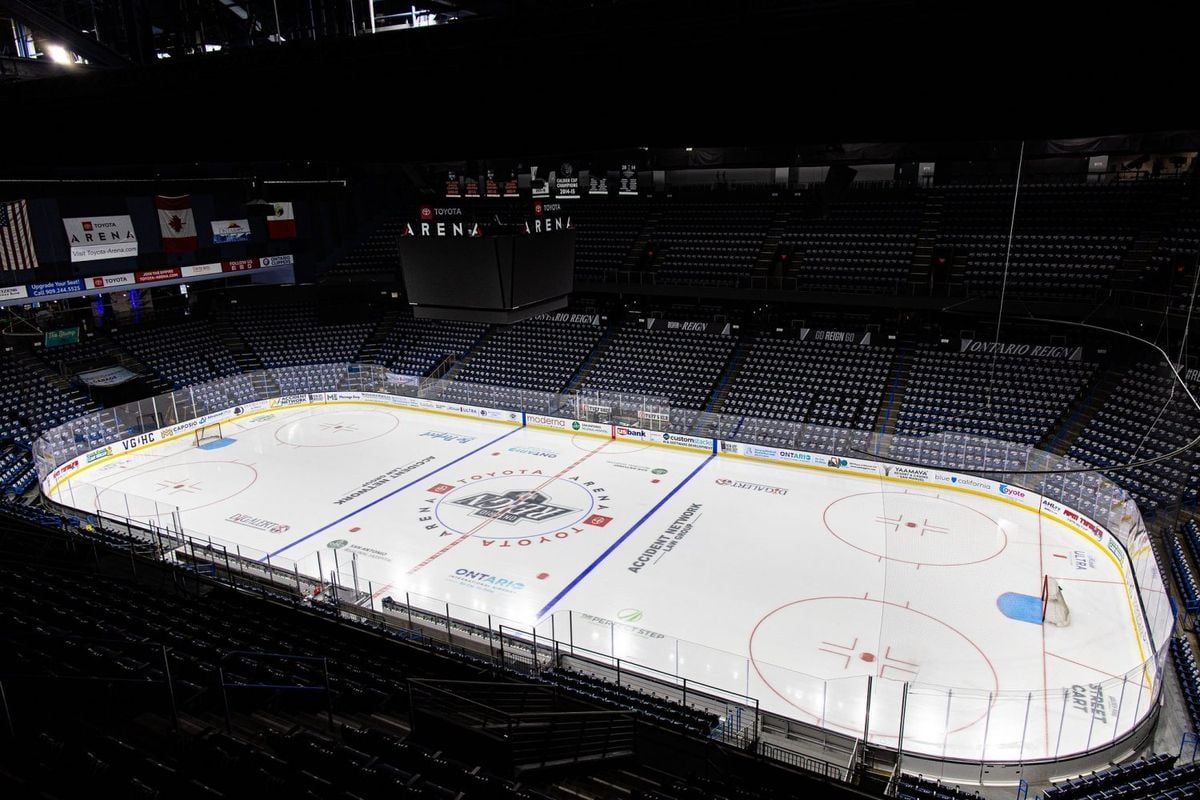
46,403 -> 1154,760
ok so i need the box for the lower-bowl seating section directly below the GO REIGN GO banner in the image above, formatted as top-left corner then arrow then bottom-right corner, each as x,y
718,337 -> 894,433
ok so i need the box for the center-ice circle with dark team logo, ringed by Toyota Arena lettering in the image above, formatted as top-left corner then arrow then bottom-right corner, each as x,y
421,470 -> 611,541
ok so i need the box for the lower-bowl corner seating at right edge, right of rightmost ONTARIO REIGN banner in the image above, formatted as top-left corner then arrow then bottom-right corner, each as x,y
1067,363 -> 1200,515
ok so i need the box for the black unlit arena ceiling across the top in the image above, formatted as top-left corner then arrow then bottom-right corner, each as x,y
0,0 -> 1200,163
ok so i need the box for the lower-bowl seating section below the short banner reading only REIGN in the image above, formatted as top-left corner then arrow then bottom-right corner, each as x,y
580,320 -> 736,410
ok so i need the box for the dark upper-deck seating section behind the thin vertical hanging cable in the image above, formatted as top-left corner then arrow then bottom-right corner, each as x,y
938,180 -> 1175,297
